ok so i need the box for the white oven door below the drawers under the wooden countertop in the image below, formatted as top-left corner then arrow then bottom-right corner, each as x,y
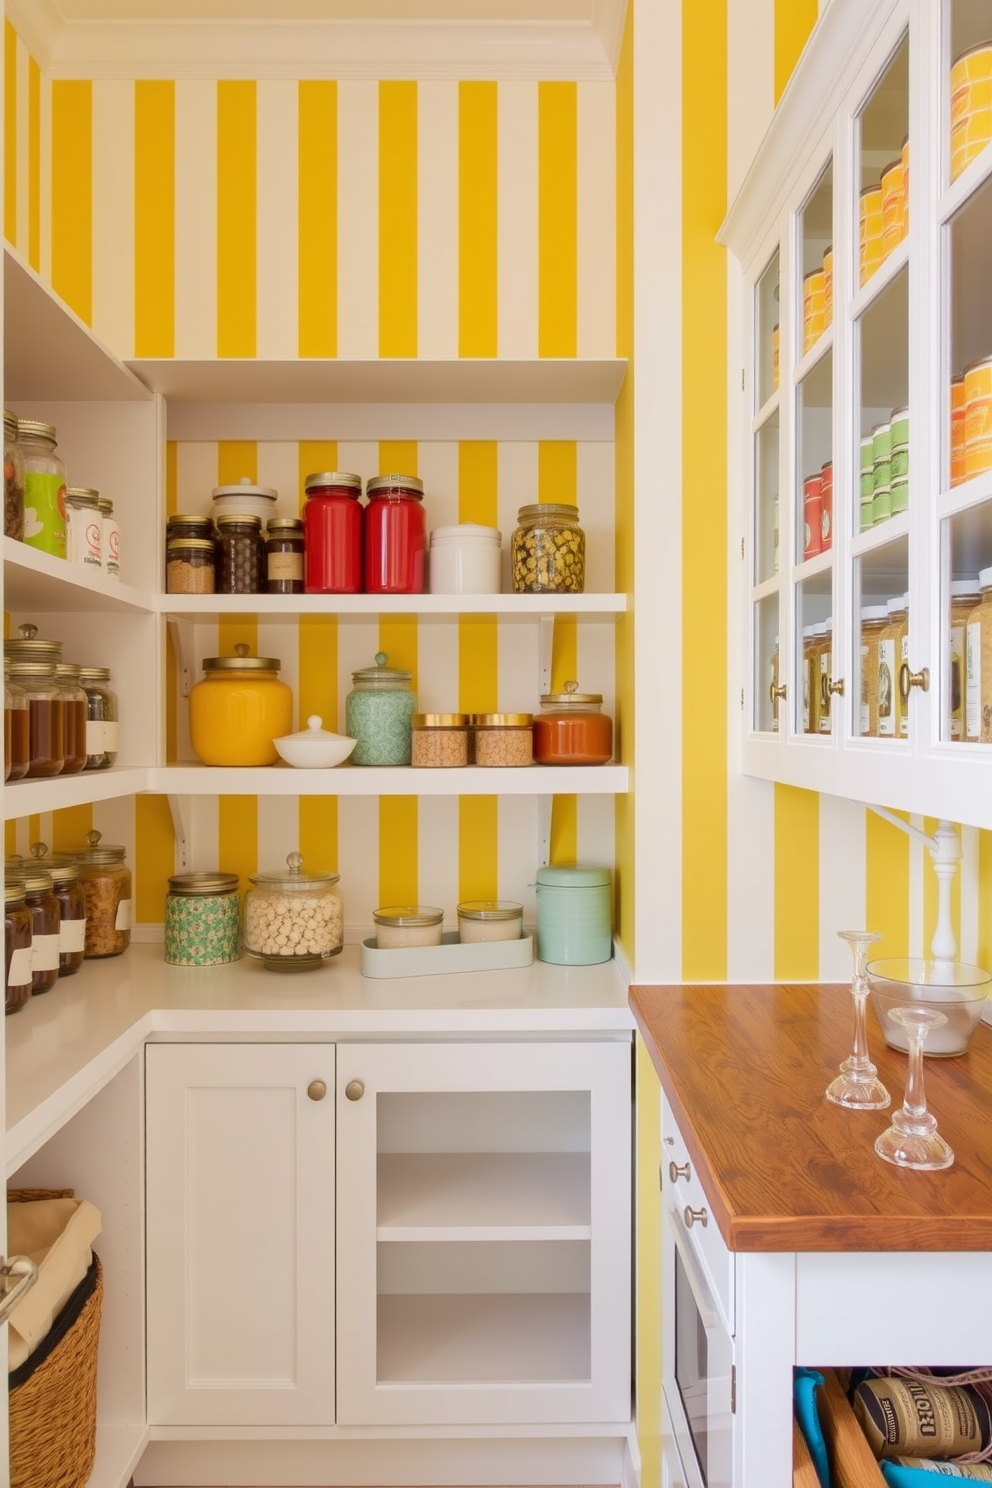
662,1204 -> 733,1488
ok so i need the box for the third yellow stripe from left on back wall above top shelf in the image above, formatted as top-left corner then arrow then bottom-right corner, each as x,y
217,80 -> 257,357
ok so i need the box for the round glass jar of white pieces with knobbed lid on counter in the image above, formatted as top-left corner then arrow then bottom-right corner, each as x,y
242,853 -> 345,972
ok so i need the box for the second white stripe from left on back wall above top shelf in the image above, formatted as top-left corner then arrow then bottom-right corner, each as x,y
175,80 -> 217,357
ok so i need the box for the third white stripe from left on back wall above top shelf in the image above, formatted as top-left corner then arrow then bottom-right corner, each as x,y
256,82 -> 299,360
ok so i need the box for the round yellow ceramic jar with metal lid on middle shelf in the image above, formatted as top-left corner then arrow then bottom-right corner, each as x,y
189,646 -> 293,765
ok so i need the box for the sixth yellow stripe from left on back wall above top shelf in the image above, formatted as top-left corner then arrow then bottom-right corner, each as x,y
458,82 -> 498,357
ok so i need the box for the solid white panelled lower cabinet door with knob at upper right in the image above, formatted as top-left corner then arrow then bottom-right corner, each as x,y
146,1045 -> 335,1426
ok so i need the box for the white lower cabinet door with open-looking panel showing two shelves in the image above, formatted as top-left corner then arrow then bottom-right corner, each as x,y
338,1043 -> 631,1426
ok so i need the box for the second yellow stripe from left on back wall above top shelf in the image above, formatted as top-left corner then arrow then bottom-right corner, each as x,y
134,80 -> 175,357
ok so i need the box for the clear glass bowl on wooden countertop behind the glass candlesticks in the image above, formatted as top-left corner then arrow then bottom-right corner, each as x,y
869,957 -> 992,1059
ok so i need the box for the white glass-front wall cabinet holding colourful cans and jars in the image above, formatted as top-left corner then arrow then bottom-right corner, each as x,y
721,0 -> 992,827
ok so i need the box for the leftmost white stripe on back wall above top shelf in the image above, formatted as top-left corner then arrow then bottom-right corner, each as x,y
92,82 -> 134,357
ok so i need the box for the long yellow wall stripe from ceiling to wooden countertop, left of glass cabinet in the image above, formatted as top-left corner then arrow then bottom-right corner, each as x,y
681,3 -> 727,981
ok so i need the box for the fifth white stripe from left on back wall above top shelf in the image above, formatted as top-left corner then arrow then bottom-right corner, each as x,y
416,82 -> 458,359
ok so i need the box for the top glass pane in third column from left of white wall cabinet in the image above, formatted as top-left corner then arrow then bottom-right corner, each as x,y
857,37 -> 909,287
